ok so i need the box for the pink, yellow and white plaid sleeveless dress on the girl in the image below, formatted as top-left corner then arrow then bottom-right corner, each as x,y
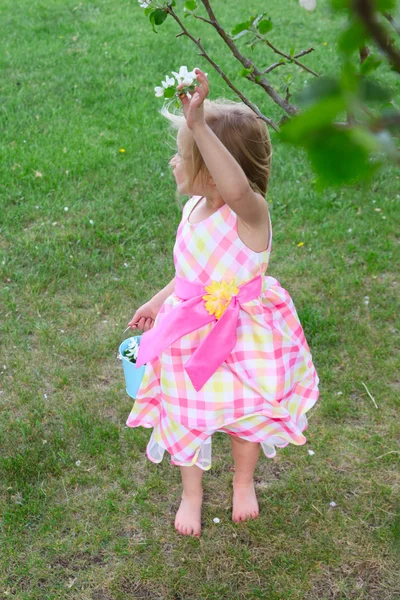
127,196 -> 319,471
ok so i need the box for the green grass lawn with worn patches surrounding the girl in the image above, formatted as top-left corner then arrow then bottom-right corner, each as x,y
0,0 -> 400,600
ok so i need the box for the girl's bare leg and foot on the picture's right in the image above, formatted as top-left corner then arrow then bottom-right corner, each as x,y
231,435 -> 261,523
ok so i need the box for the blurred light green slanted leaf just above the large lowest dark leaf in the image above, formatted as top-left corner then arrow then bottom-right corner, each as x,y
281,96 -> 346,146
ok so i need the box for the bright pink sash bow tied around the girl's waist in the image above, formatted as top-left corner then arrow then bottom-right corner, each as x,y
136,275 -> 262,391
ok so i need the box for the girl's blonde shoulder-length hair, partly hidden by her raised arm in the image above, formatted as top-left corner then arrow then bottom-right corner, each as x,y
161,98 -> 272,197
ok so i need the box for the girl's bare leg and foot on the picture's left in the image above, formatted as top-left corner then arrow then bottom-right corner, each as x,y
175,465 -> 203,537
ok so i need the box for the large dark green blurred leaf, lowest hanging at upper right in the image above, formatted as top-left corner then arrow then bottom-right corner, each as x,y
306,127 -> 380,185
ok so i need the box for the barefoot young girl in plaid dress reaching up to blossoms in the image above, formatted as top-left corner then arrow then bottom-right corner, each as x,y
127,69 -> 319,536
